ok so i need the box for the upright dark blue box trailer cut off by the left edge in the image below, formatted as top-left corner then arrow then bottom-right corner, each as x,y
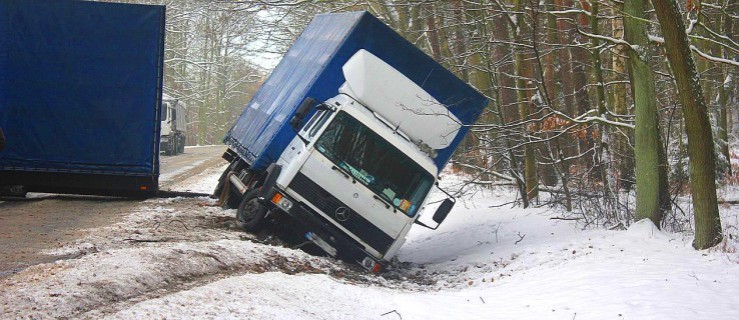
0,0 -> 165,197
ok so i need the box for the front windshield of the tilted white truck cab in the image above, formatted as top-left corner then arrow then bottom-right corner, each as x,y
316,112 -> 434,216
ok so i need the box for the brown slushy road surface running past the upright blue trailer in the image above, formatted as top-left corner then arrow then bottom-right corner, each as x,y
0,146 -> 226,278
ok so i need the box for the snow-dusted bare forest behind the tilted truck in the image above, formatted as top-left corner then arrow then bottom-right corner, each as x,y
111,0 -> 739,249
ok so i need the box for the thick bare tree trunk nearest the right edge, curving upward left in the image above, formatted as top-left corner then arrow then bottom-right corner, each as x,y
652,0 -> 722,250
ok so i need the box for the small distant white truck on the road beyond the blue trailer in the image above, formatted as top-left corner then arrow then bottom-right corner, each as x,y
159,93 -> 187,156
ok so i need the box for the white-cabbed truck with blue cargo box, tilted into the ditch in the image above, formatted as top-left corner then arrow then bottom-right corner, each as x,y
214,12 -> 487,272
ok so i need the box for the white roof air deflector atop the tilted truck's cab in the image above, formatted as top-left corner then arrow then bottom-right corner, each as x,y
339,49 -> 461,149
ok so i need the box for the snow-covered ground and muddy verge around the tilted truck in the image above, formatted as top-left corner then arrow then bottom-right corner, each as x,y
0,168 -> 739,320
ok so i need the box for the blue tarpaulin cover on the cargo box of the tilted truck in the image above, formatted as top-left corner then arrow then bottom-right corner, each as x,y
224,12 -> 487,169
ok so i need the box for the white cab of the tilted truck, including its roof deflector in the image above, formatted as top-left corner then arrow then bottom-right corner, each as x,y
223,50 -> 461,271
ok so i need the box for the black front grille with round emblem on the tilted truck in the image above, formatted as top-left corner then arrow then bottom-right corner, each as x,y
288,172 -> 395,254
